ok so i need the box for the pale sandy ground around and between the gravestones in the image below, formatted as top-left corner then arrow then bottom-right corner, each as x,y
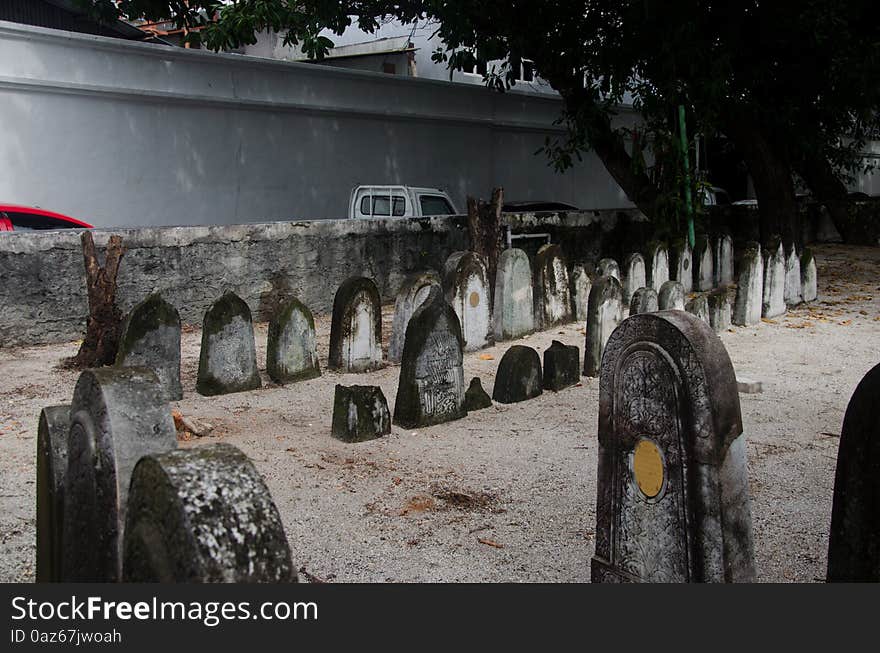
0,246 -> 880,582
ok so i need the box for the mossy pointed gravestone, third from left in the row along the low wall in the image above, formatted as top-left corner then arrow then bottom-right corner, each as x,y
266,298 -> 321,384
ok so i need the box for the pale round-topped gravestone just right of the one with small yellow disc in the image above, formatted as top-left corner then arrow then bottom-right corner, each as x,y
492,248 -> 535,340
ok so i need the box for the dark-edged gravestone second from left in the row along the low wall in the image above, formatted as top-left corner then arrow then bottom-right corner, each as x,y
196,292 -> 262,396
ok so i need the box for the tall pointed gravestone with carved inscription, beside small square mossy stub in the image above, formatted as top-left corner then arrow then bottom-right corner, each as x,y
394,286 -> 467,428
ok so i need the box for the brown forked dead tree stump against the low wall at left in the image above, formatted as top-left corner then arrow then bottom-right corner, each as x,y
65,231 -> 125,369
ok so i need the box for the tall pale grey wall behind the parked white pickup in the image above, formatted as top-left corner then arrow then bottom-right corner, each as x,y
0,22 -> 634,227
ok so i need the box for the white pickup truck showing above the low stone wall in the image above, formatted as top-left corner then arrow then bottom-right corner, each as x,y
348,186 -> 458,218
